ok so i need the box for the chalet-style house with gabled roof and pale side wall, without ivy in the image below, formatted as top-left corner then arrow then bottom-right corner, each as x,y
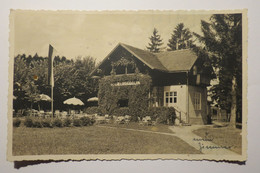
92,43 -> 211,124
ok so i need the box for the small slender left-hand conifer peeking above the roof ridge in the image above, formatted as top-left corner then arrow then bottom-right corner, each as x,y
146,28 -> 163,53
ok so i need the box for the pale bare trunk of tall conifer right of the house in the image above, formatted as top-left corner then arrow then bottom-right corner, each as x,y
229,76 -> 237,128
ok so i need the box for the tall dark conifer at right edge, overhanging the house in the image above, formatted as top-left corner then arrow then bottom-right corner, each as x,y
194,14 -> 242,127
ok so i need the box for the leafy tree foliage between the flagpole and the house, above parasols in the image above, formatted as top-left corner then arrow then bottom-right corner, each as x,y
54,57 -> 97,107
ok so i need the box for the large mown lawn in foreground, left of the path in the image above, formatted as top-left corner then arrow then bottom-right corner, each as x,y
13,126 -> 200,156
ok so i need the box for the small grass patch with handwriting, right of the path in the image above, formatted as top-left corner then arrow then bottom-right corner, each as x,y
193,126 -> 242,154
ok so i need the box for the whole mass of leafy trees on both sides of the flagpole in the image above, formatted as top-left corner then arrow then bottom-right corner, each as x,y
13,54 -> 98,110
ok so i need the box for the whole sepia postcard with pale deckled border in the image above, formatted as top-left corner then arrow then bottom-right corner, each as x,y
7,10 -> 247,161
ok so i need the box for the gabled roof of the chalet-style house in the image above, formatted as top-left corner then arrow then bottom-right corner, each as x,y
91,43 -> 198,74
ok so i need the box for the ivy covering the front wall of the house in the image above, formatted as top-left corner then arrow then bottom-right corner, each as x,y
98,74 -> 151,116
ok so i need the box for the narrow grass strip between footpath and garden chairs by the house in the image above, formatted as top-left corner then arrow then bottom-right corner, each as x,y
102,122 -> 173,133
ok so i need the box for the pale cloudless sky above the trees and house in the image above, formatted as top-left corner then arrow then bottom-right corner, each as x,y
13,10 -> 210,61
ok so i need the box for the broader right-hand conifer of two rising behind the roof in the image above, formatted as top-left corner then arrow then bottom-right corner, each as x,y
167,23 -> 193,51
